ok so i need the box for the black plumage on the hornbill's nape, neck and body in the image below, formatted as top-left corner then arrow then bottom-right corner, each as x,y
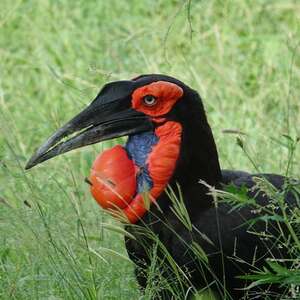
126,75 -> 294,299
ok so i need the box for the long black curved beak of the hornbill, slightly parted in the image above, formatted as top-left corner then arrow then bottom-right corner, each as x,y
25,81 -> 153,169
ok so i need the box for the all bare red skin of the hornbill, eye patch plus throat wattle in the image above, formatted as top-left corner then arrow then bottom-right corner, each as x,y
90,81 -> 183,223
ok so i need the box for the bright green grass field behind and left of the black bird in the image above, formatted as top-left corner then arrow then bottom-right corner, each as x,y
0,0 -> 300,299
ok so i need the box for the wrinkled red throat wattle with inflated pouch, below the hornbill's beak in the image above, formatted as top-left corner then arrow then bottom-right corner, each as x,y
90,121 -> 182,223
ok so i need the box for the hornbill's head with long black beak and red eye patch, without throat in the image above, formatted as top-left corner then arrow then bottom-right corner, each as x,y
26,75 -> 201,169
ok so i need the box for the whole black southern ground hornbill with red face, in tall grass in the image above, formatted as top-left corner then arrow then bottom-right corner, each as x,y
26,74 -> 293,299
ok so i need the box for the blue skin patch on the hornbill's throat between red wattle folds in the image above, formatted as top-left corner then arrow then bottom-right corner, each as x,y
125,131 -> 159,193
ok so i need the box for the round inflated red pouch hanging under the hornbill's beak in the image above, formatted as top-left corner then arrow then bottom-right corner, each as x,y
89,145 -> 136,209
